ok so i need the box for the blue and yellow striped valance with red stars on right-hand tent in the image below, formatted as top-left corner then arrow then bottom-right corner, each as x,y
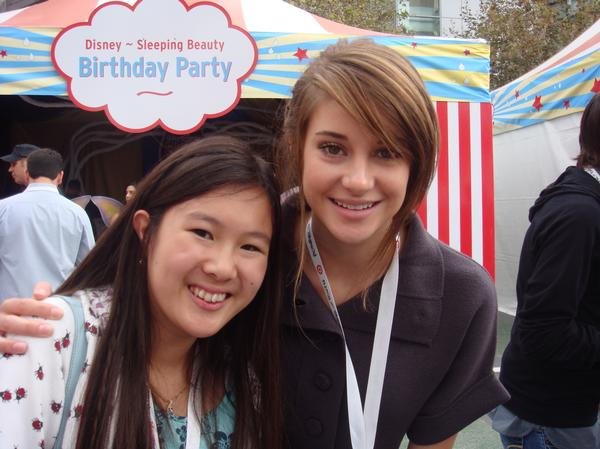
492,20 -> 600,134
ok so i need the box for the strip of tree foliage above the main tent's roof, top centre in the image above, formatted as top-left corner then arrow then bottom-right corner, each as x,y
287,0 -> 405,33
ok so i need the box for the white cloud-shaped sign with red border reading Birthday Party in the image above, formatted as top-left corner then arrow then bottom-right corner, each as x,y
52,0 -> 257,134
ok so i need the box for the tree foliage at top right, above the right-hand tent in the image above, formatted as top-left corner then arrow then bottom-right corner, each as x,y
458,0 -> 600,89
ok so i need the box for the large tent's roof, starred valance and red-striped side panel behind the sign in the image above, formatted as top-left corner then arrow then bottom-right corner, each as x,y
0,0 -> 495,275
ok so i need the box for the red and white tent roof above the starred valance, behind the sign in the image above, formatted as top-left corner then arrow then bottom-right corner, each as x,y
0,0 -> 380,35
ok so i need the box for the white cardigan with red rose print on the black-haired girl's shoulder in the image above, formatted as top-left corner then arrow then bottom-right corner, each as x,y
0,289 -> 110,449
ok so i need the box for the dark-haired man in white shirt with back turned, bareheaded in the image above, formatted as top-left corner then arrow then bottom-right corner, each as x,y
0,148 -> 94,303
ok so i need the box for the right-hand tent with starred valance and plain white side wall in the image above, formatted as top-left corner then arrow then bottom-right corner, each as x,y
492,20 -> 600,314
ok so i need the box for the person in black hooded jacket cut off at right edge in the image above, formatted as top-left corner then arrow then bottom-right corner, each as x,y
494,95 -> 600,449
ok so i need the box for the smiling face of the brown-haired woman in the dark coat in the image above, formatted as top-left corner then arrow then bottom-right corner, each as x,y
302,98 -> 410,245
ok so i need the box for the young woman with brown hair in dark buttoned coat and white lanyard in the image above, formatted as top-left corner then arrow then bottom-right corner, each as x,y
279,40 -> 507,449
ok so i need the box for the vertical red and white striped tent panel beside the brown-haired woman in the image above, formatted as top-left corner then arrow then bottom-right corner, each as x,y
418,101 -> 495,275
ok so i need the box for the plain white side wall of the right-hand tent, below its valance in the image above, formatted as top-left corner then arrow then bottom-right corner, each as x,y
494,113 -> 581,315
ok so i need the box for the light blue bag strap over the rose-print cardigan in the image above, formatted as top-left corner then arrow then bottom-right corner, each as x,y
53,296 -> 87,449
